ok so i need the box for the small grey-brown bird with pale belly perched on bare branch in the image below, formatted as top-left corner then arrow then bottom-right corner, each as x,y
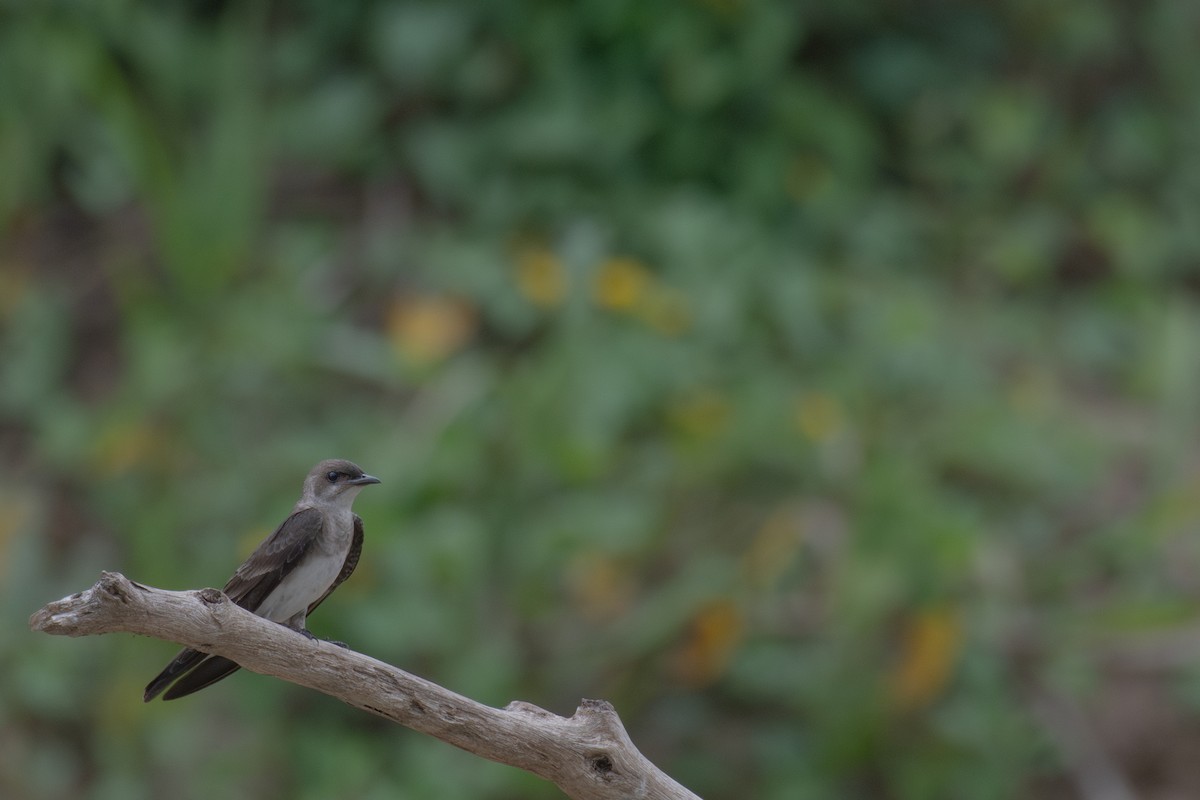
143,458 -> 379,703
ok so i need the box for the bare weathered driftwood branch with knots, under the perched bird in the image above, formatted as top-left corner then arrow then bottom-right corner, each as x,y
29,572 -> 698,800
